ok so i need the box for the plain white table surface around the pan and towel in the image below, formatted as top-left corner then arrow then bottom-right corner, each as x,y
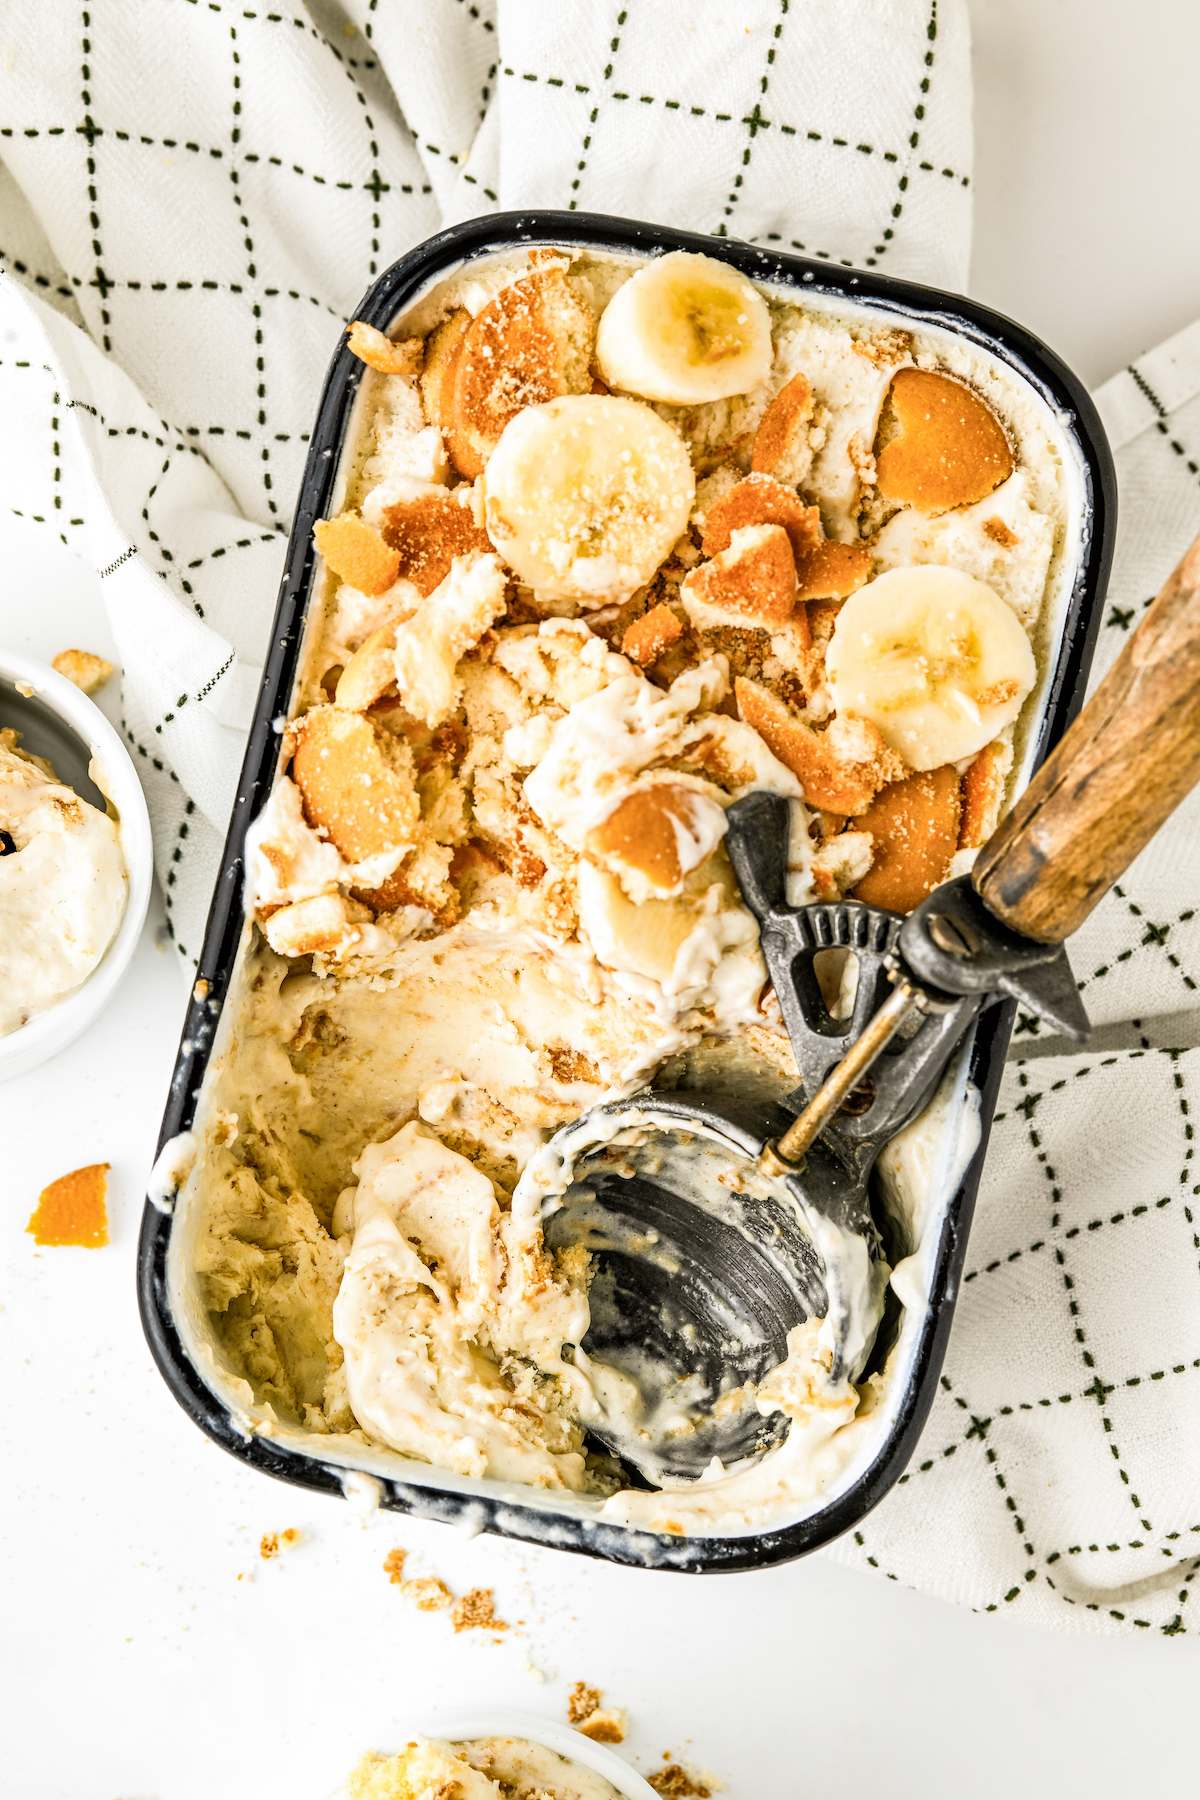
0,0 -> 1200,1800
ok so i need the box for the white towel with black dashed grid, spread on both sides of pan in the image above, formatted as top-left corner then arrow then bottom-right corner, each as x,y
0,0 -> 1200,1634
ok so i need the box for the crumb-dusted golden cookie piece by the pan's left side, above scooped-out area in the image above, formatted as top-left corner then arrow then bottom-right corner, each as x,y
291,706 -> 421,862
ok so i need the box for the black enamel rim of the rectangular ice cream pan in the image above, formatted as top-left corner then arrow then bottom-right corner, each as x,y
139,212 -> 1115,1573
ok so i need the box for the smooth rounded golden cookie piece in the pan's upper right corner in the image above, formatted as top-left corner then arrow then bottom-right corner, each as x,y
876,369 -> 1013,513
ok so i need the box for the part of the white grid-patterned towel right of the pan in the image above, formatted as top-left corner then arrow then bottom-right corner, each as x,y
829,324 -> 1200,1642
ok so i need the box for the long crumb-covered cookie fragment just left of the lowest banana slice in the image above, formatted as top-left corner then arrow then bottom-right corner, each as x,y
734,677 -> 905,813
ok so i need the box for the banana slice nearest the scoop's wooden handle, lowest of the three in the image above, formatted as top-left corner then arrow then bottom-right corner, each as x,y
826,567 -> 1038,769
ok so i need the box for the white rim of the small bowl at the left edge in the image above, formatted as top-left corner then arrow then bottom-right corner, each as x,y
0,650 -> 155,1082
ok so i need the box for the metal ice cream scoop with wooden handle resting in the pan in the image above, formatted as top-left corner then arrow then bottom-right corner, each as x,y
545,525 -> 1200,1485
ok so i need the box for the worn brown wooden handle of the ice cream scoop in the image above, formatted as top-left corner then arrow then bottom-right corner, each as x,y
972,538 -> 1200,943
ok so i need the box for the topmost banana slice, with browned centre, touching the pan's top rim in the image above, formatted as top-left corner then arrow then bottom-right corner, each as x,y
596,250 -> 772,407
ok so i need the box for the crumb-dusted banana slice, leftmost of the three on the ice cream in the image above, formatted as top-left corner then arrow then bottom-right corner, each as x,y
484,394 -> 696,607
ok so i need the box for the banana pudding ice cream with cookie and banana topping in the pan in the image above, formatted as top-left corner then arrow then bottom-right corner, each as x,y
189,248 -> 1070,1532
